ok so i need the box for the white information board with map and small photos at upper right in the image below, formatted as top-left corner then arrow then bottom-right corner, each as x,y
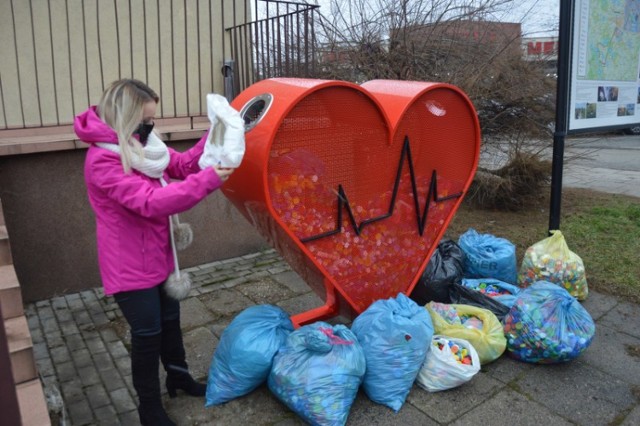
569,0 -> 640,130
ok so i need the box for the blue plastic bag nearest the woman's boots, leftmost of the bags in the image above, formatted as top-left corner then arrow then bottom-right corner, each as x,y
205,305 -> 293,407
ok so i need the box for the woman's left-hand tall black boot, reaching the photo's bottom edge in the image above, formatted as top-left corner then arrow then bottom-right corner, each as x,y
131,334 -> 176,426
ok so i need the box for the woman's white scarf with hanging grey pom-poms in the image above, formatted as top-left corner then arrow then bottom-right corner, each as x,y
96,132 -> 193,300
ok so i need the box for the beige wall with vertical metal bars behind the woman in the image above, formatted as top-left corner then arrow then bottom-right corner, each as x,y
0,0 -> 251,129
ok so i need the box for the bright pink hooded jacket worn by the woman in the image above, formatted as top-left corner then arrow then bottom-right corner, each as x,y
74,107 -> 222,294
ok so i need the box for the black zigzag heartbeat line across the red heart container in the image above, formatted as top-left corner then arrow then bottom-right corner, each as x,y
300,136 -> 462,243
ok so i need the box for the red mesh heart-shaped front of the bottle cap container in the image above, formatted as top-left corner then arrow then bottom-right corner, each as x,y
267,87 -> 476,311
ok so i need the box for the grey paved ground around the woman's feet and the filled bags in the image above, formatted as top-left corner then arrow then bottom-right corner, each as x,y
26,250 -> 640,426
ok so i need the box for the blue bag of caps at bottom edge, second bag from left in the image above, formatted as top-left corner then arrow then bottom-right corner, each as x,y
267,321 -> 366,425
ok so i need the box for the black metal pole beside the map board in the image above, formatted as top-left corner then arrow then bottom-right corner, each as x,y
549,0 -> 573,232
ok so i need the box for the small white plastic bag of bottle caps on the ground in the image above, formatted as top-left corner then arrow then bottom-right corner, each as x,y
416,335 -> 480,392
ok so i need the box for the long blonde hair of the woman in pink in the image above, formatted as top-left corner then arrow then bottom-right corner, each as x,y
98,78 -> 160,173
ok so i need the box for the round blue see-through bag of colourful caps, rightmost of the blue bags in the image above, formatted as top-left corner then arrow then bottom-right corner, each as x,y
504,281 -> 596,364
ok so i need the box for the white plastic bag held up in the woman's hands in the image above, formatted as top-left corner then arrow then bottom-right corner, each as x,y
198,93 -> 245,169
